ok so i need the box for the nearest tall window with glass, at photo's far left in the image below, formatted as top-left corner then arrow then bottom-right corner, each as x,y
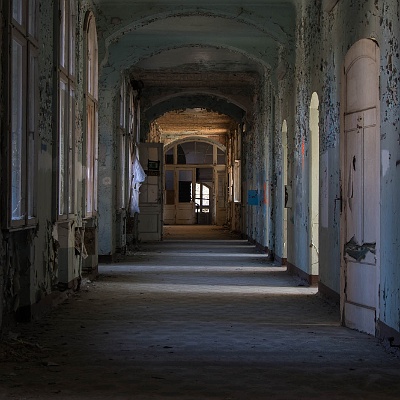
8,0 -> 38,227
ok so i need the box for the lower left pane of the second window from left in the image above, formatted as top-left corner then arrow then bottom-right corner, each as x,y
58,80 -> 68,215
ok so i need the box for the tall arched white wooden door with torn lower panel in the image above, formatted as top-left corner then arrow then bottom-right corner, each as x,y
341,39 -> 380,335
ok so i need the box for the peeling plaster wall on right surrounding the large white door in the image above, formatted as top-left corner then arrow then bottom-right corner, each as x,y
288,0 -> 400,331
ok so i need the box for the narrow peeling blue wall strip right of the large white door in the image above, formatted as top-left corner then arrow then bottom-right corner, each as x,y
375,1 -> 400,332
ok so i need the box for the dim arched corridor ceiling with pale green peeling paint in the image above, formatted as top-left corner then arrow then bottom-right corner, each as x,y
94,0 -> 300,136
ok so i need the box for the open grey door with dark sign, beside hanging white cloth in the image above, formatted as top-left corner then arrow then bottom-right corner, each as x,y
138,143 -> 163,241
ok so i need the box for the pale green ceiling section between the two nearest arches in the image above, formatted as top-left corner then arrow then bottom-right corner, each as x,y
99,12 -> 294,85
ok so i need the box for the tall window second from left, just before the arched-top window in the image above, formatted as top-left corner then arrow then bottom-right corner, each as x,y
57,0 -> 76,219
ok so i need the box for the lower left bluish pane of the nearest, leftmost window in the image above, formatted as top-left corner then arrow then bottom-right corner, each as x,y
11,40 -> 24,220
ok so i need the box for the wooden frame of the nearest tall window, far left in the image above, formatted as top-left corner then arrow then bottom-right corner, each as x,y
2,0 -> 39,230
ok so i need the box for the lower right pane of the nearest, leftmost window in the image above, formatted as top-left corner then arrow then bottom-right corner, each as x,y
27,49 -> 38,218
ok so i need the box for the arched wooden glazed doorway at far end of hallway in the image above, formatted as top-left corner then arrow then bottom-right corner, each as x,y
164,138 -> 227,225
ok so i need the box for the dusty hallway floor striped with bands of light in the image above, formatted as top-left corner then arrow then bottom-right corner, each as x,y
0,227 -> 400,400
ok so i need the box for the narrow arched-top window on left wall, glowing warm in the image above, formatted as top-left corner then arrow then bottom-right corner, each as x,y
85,13 -> 98,217
